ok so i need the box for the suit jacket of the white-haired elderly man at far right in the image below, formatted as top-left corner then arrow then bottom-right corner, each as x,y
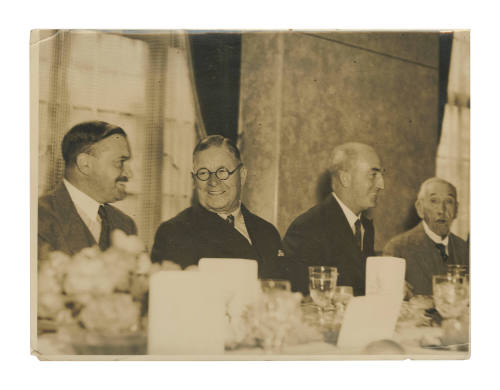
384,223 -> 469,295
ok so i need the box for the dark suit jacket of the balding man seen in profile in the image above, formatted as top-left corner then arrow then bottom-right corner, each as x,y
283,195 -> 375,295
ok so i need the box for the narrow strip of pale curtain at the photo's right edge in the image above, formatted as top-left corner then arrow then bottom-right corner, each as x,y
436,31 -> 470,239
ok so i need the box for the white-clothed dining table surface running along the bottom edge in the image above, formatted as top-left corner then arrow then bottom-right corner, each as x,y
33,300 -> 470,360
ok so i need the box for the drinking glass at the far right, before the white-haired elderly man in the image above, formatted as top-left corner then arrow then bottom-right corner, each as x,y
432,274 -> 469,319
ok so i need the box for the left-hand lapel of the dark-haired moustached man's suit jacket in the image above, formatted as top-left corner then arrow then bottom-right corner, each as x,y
55,183 -> 97,253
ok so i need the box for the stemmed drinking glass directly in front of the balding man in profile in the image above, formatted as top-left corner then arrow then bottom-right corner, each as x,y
309,266 -> 339,323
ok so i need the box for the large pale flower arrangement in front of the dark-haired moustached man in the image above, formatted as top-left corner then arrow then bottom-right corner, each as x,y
38,230 -> 180,354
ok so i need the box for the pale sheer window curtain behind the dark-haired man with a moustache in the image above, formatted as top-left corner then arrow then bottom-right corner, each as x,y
38,30 -> 204,247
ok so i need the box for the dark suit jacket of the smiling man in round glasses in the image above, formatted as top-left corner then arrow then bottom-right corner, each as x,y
151,204 -> 283,278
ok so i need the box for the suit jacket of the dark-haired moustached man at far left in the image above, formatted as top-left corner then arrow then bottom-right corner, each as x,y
38,183 -> 137,258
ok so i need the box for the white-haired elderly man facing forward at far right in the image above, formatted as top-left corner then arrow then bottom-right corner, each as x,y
384,177 -> 469,295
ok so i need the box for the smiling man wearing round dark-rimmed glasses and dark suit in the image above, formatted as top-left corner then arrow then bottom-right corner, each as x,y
151,135 -> 283,278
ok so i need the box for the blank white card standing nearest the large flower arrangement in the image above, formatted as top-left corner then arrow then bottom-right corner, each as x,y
148,271 -> 225,355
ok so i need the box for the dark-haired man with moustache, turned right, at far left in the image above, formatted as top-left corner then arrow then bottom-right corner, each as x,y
38,121 -> 137,258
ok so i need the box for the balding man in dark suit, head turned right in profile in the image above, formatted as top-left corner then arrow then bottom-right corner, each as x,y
284,142 -> 384,295
